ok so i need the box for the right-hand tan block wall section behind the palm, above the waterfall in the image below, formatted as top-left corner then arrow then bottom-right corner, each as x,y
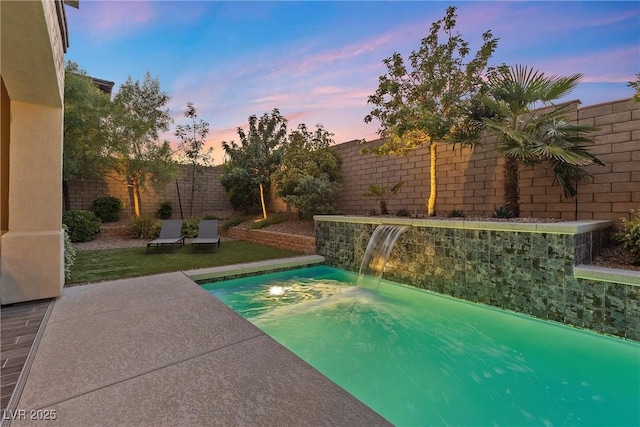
334,100 -> 640,227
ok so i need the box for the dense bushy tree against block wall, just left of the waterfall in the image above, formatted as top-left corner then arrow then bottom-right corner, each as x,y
273,123 -> 342,218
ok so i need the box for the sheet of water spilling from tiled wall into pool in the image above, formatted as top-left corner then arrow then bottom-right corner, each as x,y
358,224 -> 407,286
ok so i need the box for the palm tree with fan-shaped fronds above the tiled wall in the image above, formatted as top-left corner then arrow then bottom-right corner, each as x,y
484,65 -> 603,216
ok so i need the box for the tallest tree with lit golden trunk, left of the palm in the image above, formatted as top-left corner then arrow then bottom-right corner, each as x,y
363,6 -> 498,216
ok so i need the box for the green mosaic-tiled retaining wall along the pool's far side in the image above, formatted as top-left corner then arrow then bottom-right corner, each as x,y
315,216 -> 640,341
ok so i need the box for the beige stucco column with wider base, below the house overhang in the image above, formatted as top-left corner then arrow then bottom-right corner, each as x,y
0,101 -> 64,304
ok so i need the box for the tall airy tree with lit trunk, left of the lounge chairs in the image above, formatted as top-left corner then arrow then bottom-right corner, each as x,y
107,72 -> 177,217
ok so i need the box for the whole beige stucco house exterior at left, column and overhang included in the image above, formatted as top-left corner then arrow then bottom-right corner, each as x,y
0,0 -> 72,304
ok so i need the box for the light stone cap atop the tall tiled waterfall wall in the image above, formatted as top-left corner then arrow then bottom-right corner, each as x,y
313,215 -> 613,234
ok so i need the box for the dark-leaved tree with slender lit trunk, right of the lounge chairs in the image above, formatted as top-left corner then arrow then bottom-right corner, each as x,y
220,108 -> 287,219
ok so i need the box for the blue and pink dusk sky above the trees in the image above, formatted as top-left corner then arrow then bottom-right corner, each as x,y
66,0 -> 640,163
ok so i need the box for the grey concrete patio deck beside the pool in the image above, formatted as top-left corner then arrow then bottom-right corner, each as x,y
3,273 -> 390,426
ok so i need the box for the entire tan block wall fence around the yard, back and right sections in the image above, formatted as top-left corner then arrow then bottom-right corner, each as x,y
69,99 -> 640,223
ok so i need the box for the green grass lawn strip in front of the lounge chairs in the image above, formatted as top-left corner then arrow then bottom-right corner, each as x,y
65,240 -> 302,286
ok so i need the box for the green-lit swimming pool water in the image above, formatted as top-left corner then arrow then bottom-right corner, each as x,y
203,266 -> 640,426
